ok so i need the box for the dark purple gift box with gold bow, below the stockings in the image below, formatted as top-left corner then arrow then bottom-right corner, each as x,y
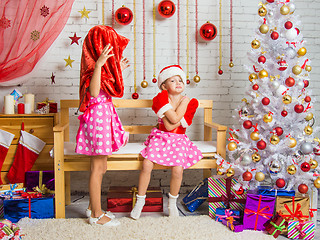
25,171 -> 54,195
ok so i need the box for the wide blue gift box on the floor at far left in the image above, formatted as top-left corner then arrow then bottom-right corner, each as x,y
3,197 -> 54,223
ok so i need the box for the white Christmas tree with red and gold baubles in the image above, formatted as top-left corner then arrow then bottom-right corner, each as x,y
217,0 -> 320,193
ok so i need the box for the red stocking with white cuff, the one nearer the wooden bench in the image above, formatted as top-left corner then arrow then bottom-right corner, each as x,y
7,131 -> 46,183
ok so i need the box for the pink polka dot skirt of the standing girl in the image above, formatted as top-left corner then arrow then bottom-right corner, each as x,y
76,90 -> 129,155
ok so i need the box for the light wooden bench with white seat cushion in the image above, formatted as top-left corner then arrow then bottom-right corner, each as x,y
53,99 -> 227,218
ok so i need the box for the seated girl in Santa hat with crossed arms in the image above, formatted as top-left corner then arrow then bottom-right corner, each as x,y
130,65 -> 202,219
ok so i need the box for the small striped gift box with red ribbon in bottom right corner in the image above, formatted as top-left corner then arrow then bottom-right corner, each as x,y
287,220 -> 315,240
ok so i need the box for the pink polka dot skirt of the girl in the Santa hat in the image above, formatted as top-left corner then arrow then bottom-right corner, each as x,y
141,118 -> 202,169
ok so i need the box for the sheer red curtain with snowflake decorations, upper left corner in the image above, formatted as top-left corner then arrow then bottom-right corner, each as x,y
0,0 -> 74,86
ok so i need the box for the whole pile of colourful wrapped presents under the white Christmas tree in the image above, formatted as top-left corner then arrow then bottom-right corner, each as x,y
183,176 -> 317,239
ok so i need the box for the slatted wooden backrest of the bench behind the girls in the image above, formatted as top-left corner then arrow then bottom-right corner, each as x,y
60,99 -> 213,141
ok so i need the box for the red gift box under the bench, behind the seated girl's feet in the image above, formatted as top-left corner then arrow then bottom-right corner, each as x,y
107,187 -> 163,212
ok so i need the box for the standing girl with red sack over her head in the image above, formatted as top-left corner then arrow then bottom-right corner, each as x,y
76,26 -> 129,226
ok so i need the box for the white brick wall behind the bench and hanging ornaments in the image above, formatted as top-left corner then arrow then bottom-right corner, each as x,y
0,0 -> 320,191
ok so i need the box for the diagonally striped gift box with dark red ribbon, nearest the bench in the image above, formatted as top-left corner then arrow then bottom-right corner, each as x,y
208,176 -> 247,219
